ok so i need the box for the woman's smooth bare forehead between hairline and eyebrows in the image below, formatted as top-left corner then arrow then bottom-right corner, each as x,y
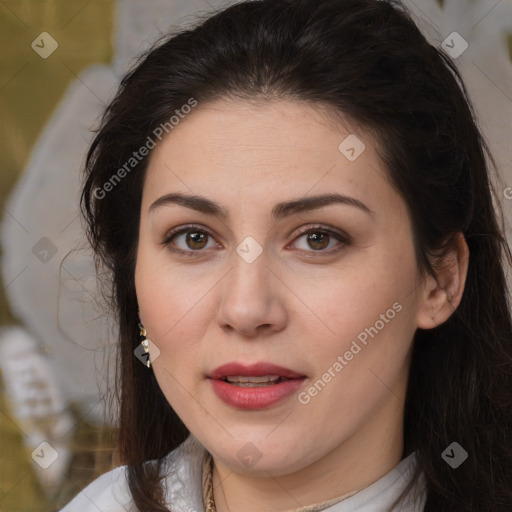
144,100 -> 396,216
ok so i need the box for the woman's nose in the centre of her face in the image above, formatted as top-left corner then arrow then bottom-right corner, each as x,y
218,251 -> 288,337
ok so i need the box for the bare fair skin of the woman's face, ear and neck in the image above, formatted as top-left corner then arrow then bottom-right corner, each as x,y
135,100 -> 468,512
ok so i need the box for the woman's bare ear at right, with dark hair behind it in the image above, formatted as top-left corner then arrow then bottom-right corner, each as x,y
417,233 -> 469,329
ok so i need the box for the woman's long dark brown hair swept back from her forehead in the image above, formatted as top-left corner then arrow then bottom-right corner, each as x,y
82,0 -> 512,512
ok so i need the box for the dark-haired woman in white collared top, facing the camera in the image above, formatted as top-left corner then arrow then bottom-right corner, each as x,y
58,0 -> 512,512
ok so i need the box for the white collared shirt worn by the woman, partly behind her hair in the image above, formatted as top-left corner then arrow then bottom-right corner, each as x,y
60,435 -> 426,512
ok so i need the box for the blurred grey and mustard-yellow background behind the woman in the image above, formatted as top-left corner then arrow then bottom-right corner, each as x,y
0,0 -> 512,512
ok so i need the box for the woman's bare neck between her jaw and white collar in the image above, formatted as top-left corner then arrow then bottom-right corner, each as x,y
213,395 -> 403,512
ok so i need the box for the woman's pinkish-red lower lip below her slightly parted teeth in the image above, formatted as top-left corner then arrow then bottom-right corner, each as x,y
209,377 -> 305,409
